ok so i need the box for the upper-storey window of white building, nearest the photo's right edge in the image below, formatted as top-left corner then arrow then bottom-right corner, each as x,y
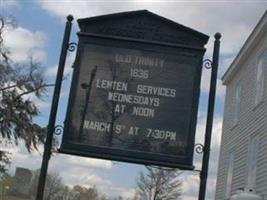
255,54 -> 264,105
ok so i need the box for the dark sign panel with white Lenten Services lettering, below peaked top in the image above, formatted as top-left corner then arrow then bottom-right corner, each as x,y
61,9 -> 209,169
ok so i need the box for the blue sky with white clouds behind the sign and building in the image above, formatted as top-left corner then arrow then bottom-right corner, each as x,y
0,0 -> 267,200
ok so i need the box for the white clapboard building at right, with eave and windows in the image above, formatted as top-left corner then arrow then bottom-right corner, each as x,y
215,12 -> 267,200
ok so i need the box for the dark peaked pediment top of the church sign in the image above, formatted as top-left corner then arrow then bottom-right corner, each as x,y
78,10 -> 209,48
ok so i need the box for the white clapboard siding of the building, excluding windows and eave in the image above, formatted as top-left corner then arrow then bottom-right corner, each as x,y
215,31 -> 267,200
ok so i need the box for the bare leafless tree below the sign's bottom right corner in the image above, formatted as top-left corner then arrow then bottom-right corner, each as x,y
136,166 -> 182,200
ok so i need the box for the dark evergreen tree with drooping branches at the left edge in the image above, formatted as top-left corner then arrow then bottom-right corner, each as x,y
0,16 -> 52,174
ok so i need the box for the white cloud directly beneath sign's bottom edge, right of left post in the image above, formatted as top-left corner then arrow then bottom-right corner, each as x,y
50,154 -> 134,198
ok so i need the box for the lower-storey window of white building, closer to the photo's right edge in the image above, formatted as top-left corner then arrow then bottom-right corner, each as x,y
247,136 -> 259,187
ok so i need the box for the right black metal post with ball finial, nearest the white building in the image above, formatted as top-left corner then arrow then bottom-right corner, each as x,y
198,33 -> 221,200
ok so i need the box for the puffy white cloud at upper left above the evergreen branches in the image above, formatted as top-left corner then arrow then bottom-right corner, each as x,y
3,27 -> 46,62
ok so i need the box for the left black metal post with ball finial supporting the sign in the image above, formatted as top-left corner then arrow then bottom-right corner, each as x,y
36,15 -> 73,200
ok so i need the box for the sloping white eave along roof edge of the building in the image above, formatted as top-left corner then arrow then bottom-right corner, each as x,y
222,11 -> 267,85
